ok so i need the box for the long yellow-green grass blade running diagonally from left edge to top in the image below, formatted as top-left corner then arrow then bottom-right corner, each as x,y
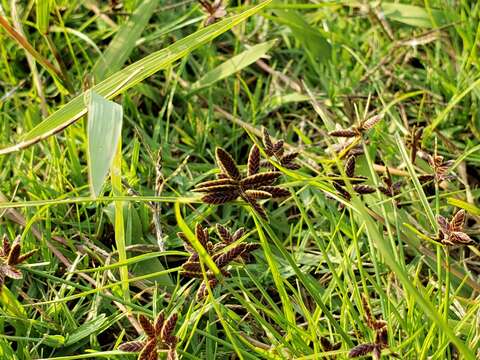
0,0 -> 272,155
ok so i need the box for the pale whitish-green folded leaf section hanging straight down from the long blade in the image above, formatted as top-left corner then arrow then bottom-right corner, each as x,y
87,92 -> 123,197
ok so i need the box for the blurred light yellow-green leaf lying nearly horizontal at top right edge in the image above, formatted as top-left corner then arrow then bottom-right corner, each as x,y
381,2 -> 447,28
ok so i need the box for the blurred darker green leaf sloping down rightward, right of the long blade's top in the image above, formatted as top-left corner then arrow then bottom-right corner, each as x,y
273,10 -> 332,62
